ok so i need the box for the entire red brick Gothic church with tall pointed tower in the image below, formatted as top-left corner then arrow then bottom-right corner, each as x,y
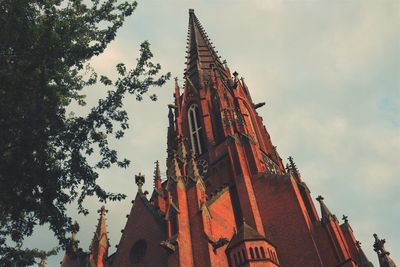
61,10 -> 395,267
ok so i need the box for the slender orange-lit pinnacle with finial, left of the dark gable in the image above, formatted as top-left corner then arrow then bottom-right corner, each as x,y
89,206 -> 110,267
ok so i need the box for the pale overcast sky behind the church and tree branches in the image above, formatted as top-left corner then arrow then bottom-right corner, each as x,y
28,0 -> 400,266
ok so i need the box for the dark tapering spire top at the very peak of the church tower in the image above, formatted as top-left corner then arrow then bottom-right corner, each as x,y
185,9 -> 229,88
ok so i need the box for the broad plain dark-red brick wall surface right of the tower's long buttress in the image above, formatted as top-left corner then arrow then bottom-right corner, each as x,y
254,176 -> 322,267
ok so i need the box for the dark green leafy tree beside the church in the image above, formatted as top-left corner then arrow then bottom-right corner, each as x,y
0,0 -> 170,266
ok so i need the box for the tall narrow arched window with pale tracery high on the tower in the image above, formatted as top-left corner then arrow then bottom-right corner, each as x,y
188,104 -> 204,155
